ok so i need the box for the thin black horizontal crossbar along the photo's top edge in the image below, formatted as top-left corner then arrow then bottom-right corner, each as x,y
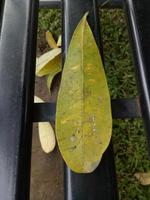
40,0 -> 122,8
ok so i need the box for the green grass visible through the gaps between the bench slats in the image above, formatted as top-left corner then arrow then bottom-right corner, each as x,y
38,10 -> 150,200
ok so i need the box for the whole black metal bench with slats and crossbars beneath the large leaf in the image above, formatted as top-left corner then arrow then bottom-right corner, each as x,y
0,0 -> 150,200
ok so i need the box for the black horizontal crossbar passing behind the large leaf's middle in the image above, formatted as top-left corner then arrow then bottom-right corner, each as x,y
33,99 -> 141,122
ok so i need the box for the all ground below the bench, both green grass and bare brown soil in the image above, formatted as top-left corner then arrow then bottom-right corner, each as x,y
31,10 -> 150,200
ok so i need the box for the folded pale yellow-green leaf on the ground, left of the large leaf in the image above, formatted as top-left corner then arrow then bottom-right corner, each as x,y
36,48 -> 61,77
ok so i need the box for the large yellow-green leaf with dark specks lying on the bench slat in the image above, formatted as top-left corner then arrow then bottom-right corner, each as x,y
56,14 -> 112,173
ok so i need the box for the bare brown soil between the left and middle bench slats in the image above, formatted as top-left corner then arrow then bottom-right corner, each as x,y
30,78 -> 63,200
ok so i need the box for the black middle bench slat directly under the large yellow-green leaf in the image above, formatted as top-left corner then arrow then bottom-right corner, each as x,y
62,0 -> 118,200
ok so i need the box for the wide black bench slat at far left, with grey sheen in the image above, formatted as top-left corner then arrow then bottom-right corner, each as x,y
0,0 -> 38,200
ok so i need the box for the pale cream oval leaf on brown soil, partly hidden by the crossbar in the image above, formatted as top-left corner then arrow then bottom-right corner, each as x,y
34,96 -> 56,153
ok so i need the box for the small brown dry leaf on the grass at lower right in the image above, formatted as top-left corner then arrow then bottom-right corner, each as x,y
134,172 -> 150,186
